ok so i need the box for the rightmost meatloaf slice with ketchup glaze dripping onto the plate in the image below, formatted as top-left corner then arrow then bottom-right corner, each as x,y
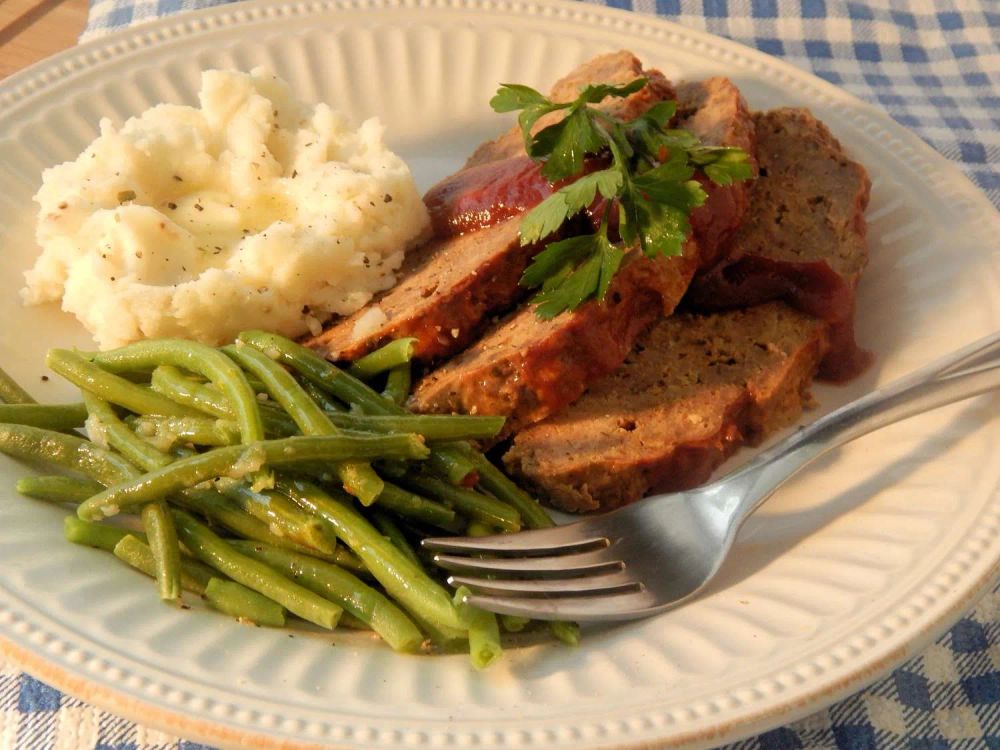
686,108 -> 871,380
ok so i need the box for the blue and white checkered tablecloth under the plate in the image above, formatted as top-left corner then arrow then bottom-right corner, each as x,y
0,0 -> 1000,750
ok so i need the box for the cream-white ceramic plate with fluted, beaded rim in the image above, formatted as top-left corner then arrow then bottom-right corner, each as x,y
0,0 -> 1000,748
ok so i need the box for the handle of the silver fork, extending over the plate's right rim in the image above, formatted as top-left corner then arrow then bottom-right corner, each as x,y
724,332 -> 1000,534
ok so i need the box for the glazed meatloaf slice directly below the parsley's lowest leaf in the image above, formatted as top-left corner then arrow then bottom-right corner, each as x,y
411,242 -> 698,437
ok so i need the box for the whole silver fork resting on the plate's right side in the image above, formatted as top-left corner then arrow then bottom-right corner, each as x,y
423,333 -> 1000,621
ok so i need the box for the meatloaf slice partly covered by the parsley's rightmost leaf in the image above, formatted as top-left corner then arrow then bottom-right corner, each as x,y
677,77 -> 756,267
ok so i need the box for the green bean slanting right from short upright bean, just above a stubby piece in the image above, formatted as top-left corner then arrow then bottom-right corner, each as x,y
174,510 -> 343,629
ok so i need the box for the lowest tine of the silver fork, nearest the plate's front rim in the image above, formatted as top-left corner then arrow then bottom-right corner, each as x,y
468,589 -> 662,621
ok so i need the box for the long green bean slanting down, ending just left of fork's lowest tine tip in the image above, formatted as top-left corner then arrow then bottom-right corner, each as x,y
277,480 -> 462,629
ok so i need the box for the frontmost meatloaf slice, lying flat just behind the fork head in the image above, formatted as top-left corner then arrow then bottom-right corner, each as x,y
503,302 -> 827,511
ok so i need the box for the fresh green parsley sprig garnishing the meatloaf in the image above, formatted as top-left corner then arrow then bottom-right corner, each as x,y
490,78 -> 752,319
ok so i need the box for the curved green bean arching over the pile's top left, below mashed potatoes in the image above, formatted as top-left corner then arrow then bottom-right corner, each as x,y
94,339 -> 264,444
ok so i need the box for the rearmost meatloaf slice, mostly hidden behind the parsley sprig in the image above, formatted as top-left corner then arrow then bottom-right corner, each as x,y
465,50 -> 675,167
